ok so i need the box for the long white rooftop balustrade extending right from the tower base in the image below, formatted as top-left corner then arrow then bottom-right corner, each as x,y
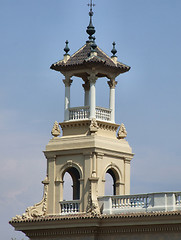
98,192 -> 181,214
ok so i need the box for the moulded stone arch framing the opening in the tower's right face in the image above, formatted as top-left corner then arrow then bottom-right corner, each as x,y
102,163 -> 122,195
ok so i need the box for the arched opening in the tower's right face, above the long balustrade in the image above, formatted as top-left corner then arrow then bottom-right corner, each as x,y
105,168 -> 119,195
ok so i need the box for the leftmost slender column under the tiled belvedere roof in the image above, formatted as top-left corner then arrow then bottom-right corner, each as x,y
63,77 -> 72,121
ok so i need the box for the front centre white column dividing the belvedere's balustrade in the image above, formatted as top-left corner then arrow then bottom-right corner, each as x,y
88,74 -> 97,119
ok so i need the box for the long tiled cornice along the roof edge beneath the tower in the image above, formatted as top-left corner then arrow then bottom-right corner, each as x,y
10,212 -> 181,237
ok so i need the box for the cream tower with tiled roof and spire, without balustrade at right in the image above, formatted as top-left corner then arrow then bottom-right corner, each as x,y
10,4 -> 136,239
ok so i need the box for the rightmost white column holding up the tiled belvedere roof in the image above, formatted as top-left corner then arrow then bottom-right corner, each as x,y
107,79 -> 117,123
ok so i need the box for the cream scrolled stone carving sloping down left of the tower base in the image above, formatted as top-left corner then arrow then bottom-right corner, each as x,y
11,184 -> 48,221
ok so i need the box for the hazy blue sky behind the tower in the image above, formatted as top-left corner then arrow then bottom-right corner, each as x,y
0,0 -> 181,240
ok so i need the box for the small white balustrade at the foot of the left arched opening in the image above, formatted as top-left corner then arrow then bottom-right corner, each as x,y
60,200 -> 80,215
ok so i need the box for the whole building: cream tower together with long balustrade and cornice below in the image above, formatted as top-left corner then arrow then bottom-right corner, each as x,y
10,1 -> 181,240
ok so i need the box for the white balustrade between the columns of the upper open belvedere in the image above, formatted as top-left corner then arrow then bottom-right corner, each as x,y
69,106 -> 111,121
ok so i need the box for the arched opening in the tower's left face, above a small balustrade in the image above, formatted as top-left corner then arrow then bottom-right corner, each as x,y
63,167 -> 80,200
